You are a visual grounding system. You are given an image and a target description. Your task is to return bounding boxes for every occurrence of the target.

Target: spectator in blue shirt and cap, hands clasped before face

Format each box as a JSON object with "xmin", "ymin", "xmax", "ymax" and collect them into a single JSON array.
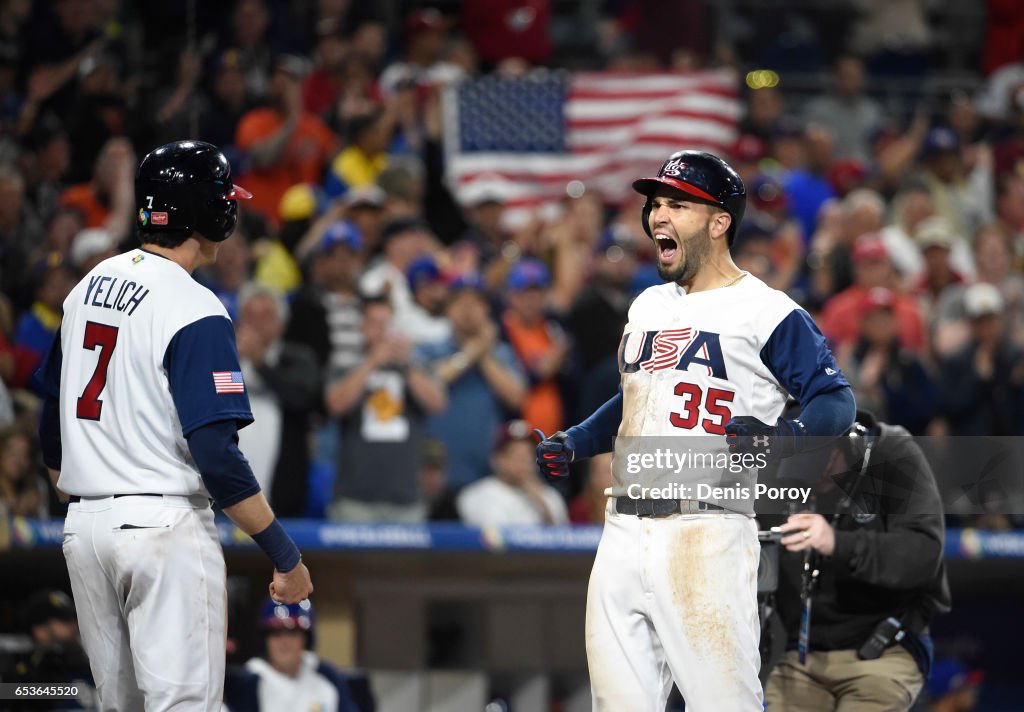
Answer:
[{"xmin": 420, "ymin": 274, "xmax": 526, "ymax": 488}]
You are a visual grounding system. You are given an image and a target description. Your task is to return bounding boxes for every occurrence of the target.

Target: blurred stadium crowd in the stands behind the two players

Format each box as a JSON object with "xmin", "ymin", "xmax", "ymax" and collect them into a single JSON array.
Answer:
[{"xmin": 0, "ymin": 0, "xmax": 1024, "ymax": 528}]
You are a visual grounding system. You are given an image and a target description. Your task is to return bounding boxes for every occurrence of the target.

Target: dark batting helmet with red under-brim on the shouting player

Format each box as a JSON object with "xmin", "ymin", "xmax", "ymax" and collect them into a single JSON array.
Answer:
[{"xmin": 633, "ymin": 151, "xmax": 746, "ymax": 246}]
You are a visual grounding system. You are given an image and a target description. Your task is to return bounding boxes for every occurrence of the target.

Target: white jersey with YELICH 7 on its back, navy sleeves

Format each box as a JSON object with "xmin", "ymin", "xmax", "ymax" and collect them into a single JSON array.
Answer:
[{"xmin": 43, "ymin": 250, "xmax": 252, "ymax": 496}]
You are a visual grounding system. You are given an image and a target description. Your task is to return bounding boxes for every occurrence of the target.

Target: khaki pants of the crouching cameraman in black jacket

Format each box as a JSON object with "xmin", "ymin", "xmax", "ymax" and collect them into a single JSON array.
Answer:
[{"xmin": 765, "ymin": 645, "xmax": 925, "ymax": 712}]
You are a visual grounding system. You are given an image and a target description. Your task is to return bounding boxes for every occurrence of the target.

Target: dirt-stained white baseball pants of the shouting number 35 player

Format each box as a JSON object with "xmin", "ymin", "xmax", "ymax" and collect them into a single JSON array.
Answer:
[{"xmin": 587, "ymin": 500, "xmax": 763, "ymax": 712}]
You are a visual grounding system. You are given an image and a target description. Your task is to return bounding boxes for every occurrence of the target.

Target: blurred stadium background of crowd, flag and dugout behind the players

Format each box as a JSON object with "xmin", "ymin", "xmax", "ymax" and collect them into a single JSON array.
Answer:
[{"xmin": 0, "ymin": 0, "xmax": 1024, "ymax": 712}]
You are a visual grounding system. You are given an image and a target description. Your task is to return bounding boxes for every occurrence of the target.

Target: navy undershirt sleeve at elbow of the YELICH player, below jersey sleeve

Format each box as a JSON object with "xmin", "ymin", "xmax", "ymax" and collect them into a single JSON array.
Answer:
[{"xmin": 188, "ymin": 420, "xmax": 260, "ymax": 509}]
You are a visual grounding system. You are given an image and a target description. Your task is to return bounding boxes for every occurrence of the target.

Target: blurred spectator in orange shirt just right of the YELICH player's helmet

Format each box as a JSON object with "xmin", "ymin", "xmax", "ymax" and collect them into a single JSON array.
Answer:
[{"xmin": 234, "ymin": 55, "xmax": 338, "ymax": 226}]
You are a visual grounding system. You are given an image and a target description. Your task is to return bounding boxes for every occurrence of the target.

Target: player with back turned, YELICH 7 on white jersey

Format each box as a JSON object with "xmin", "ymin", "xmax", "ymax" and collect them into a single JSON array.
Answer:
[{"xmin": 40, "ymin": 141, "xmax": 312, "ymax": 712}]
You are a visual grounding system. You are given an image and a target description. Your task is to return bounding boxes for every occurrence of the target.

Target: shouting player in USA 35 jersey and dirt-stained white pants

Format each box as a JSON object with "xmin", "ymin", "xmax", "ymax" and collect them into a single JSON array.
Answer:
[{"xmin": 538, "ymin": 151, "xmax": 855, "ymax": 712}]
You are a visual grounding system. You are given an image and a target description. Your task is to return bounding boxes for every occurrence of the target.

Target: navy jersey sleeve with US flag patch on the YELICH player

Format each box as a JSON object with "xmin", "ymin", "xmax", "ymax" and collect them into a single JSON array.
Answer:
[{"xmin": 164, "ymin": 317, "xmax": 253, "ymax": 437}]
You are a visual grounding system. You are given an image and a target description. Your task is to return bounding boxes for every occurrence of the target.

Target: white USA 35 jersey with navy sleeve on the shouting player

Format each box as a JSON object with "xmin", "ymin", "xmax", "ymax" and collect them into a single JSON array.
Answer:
[{"xmin": 612, "ymin": 275, "xmax": 847, "ymax": 513}]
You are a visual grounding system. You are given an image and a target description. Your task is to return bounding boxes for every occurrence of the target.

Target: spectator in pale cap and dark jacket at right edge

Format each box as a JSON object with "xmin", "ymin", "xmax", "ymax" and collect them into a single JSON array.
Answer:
[{"xmin": 939, "ymin": 282, "xmax": 1024, "ymax": 435}]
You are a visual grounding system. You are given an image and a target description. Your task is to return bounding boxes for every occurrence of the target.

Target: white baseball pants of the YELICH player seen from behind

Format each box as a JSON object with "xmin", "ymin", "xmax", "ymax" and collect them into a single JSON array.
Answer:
[{"xmin": 63, "ymin": 496, "xmax": 226, "ymax": 712}]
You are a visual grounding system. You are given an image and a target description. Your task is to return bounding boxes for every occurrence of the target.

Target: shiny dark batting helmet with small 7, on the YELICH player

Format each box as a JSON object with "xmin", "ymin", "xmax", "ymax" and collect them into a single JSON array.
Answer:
[{"xmin": 135, "ymin": 141, "xmax": 252, "ymax": 247}]
